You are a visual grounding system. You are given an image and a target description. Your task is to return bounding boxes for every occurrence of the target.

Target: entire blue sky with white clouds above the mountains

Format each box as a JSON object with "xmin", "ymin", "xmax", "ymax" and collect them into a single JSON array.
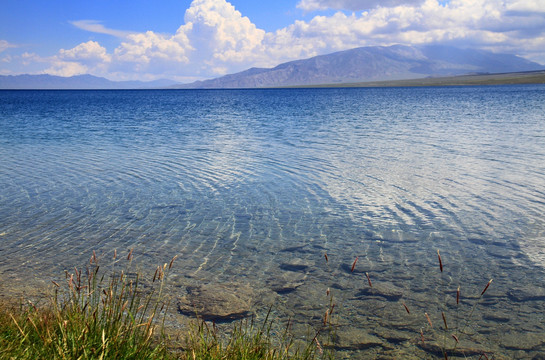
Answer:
[{"xmin": 0, "ymin": 0, "xmax": 545, "ymax": 82}]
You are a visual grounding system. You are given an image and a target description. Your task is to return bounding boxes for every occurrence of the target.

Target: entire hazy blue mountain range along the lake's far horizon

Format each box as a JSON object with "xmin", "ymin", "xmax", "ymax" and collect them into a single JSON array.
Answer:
[{"xmin": 0, "ymin": 45, "xmax": 545, "ymax": 89}]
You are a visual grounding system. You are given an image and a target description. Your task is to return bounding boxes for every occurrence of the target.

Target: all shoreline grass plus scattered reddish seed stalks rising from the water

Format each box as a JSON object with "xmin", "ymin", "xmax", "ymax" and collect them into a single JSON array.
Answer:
[{"xmin": 0, "ymin": 250, "xmax": 497, "ymax": 360}]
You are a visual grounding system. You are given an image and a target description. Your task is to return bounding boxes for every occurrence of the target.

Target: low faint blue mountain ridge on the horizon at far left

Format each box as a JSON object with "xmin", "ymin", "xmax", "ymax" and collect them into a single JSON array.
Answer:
[{"xmin": 0, "ymin": 75, "xmax": 181, "ymax": 90}]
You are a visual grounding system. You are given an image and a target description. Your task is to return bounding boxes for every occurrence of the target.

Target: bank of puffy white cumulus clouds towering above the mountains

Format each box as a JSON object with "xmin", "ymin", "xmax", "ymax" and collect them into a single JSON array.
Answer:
[{"xmin": 18, "ymin": 0, "xmax": 545, "ymax": 80}]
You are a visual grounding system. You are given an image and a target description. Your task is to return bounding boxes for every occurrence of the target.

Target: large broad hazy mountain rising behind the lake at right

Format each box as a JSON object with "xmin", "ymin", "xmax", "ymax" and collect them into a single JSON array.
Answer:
[{"xmin": 176, "ymin": 45, "xmax": 545, "ymax": 88}]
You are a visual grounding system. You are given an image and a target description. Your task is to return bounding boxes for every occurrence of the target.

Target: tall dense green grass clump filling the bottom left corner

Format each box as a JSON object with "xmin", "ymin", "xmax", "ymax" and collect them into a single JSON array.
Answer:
[{"xmin": 0, "ymin": 252, "xmax": 172, "ymax": 360}]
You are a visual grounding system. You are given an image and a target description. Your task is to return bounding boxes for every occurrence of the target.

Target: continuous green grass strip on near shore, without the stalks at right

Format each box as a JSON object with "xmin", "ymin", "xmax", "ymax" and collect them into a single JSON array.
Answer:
[{"xmin": 0, "ymin": 253, "xmax": 332, "ymax": 360}]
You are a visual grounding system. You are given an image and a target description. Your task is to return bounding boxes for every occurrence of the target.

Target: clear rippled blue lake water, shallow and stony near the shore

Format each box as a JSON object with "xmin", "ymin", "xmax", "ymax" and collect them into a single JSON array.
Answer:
[{"xmin": 0, "ymin": 86, "xmax": 545, "ymax": 358}]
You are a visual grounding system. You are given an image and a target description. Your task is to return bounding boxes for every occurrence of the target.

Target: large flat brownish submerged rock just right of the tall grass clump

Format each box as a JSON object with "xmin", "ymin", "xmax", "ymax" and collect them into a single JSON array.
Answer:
[{"xmin": 178, "ymin": 283, "xmax": 254, "ymax": 321}]
